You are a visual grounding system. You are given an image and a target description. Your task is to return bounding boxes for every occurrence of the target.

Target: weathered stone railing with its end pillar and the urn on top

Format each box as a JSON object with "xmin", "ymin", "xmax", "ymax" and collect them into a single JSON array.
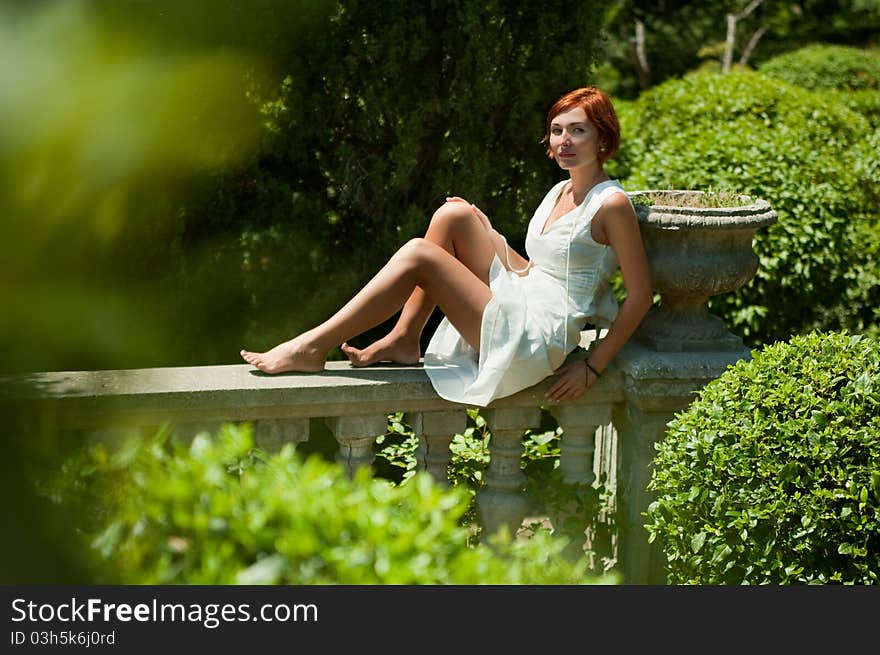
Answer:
[{"xmin": 6, "ymin": 191, "xmax": 776, "ymax": 584}]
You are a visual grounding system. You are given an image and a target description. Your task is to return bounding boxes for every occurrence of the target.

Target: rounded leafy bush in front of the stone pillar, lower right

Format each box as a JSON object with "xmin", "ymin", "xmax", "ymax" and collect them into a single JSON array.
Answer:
[{"xmin": 646, "ymin": 332, "xmax": 880, "ymax": 584}]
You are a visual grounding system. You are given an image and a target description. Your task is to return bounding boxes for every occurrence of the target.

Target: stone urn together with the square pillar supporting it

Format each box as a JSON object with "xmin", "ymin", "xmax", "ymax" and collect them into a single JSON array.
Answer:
[{"xmin": 614, "ymin": 191, "xmax": 776, "ymax": 584}]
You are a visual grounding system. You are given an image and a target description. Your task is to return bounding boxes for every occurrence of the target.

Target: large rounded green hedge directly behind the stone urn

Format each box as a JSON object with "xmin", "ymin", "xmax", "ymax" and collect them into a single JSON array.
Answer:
[{"xmin": 611, "ymin": 69, "xmax": 880, "ymax": 346}]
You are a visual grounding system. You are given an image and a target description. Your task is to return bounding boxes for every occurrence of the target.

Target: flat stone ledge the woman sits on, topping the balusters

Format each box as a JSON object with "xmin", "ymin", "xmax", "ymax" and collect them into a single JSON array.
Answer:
[{"xmin": 0, "ymin": 362, "xmax": 622, "ymax": 428}]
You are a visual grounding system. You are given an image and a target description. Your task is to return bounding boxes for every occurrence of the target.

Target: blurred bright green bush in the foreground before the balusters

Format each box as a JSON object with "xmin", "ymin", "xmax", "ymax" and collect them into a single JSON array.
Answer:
[{"xmin": 50, "ymin": 426, "xmax": 612, "ymax": 584}]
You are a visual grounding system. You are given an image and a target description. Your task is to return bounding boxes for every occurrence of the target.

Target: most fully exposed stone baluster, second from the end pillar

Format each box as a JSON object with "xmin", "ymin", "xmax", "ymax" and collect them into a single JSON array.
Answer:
[{"xmin": 477, "ymin": 407, "xmax": 541, "ymax": 536}]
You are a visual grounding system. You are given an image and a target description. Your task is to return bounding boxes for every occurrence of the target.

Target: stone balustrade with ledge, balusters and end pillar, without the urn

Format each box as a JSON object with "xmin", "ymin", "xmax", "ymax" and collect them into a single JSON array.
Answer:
[{"xmin": 0, "ymin": 330, "xmax": 749, "ymax": 584}]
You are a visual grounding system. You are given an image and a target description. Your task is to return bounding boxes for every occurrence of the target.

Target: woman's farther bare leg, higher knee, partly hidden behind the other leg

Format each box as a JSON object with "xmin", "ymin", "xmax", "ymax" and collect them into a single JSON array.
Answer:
[{"xmin": 342, "ymin": 202, "xmax": 496, "ymax": 366}]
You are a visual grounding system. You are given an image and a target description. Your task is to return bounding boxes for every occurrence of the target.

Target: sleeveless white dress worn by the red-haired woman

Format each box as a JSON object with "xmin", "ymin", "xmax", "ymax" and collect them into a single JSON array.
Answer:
[{"xmin": 424, "ymin": 180, "xmax": 625, "ymax": 407}]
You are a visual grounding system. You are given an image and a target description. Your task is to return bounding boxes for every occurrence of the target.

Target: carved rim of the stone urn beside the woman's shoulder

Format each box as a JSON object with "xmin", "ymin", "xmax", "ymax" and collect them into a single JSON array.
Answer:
[{"xmin": 627, "ymin": 189, "xmax": 777, "ymax": 230}]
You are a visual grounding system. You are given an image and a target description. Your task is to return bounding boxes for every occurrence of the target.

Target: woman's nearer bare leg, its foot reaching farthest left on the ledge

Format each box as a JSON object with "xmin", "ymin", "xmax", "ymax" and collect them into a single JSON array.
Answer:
[{"xmin": 241, "ymin": 232, "xmax": 494, "ymax": 373}]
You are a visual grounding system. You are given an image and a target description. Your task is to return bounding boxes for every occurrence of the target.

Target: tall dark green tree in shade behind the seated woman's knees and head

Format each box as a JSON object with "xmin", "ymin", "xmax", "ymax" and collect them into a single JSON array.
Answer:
[{"xmin": 178, "ymin": 0, "xmax": 601, "ymax": 357}]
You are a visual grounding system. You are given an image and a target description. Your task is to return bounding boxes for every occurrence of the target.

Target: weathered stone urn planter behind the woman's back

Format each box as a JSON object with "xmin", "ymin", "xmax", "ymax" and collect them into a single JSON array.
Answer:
[{"xmin": 629, "ymin": 190, "xmax": 776, "ymax": 352}]
